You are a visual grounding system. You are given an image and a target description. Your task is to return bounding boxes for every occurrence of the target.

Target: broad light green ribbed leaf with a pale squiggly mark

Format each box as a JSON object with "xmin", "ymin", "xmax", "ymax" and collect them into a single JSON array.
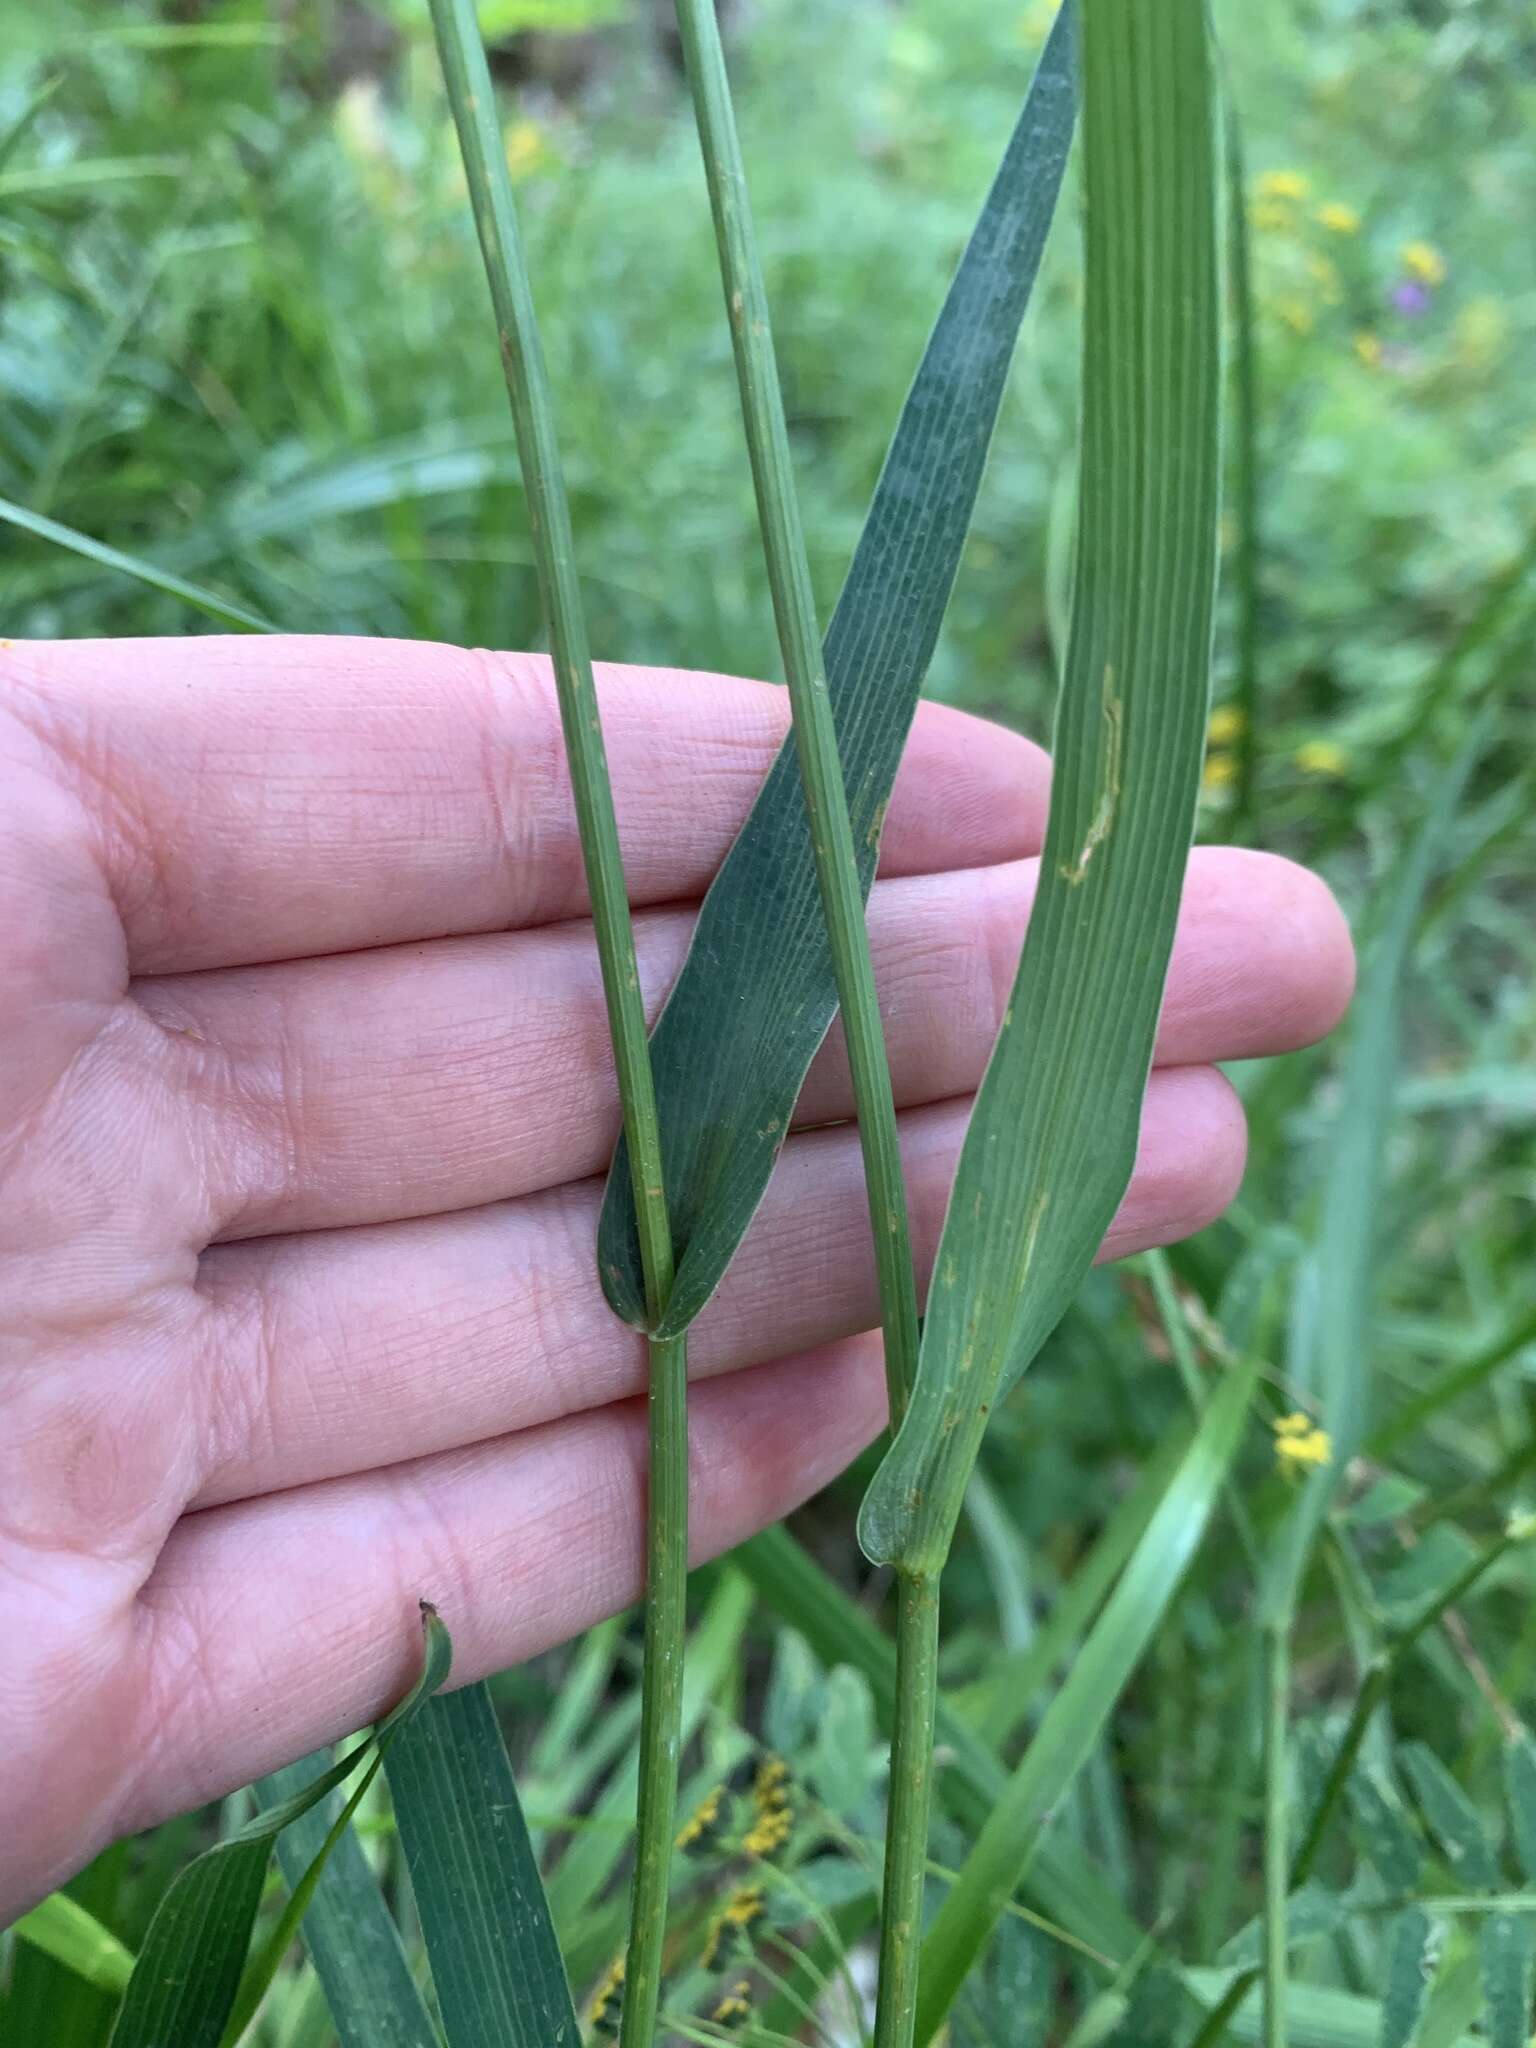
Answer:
[{"xmin": 860, "ymin": 0, "xmax": 1221, "ymax": 1573}]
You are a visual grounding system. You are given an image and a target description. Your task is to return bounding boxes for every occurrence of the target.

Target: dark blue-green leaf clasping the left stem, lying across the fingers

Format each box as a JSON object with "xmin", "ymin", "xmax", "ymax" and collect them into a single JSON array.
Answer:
[{"xmin": 598, "ymin": 8, "xmax": 1075, "ymax": 1335}]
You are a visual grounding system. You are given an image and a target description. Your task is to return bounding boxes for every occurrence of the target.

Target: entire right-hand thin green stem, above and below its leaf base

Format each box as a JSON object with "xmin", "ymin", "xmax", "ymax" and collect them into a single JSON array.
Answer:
[{"xmin": 663, "ymin": 0, "xmax": 921, "ymax": 2048}]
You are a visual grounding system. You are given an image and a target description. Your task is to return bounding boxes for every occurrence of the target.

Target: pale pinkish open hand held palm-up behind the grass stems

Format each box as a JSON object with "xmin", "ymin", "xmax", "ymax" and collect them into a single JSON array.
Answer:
[{"xmin": 0, "ymin": 639, "xmax": 1354, "ymax": 1923}]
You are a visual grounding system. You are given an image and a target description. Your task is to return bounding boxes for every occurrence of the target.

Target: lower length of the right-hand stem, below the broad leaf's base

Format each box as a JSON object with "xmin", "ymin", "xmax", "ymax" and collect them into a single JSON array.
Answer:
[{"xmin": 874, "ymin": 1571, "xmax": 938, "ymax": 2048}]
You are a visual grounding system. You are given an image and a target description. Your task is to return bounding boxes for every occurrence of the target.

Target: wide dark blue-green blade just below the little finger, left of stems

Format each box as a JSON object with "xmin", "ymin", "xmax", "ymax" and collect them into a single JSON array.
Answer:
[{"xmin": 385, "ymin": 1686, "xmax": 580, "ymax": 2048}]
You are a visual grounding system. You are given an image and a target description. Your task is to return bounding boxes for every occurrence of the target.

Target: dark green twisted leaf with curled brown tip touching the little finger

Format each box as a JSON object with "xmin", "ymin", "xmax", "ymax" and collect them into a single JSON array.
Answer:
[{"xmin": 113, "ymin": 1608, "xmax": 453, "ymax": 2048}]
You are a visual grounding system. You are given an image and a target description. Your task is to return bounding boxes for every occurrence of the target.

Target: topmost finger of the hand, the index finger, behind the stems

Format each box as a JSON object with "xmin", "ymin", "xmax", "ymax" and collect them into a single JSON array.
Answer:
[{"xmin": 0, "ymin": 635, "xmax": 1047, "ymax": 973}]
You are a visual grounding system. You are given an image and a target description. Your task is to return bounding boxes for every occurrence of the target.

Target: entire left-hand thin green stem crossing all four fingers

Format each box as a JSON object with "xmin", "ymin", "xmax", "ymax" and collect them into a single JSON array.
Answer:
[{"xmin": 421, "ymin": 0, "xmax": 688, "ymax": 2048}]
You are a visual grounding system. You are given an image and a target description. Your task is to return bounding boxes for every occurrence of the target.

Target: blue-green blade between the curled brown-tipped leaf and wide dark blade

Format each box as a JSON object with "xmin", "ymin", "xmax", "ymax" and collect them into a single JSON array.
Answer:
[{"xmin": 256, "ymin": 1751, "xmax": 438, "ymax": 2048}]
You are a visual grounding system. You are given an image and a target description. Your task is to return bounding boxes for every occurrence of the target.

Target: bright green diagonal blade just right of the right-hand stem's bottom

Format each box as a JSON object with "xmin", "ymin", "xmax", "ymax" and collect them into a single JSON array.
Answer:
[{"xmin": 918, "ymin": 1362, "xmax": 1257, "ymax": 2042}]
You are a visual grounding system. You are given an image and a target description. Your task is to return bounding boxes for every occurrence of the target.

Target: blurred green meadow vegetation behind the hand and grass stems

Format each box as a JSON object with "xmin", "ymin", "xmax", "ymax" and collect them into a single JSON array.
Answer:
[{"xmin": 0, "ymin": 0, "xmax": 1536, "ymax": 2048}]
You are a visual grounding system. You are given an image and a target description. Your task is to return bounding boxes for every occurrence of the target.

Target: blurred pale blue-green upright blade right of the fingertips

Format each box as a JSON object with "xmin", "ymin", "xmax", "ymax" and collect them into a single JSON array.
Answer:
[{"xmin": 1264, "ymin": 719, "xmax": 1487, "ymax": 1614}]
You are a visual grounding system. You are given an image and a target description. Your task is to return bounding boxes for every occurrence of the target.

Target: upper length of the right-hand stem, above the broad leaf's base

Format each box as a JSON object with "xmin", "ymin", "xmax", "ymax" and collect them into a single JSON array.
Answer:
[{"xmin": 678, "ymin": 0, "xmax": 918, "ymax": 1427}]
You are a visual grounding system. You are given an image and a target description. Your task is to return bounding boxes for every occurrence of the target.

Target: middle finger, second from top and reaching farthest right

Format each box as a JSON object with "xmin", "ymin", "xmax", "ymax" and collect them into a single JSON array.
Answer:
[{"xmin": 135, "ymin": 848, "xmax": 1350, "ymax": 1241}]
